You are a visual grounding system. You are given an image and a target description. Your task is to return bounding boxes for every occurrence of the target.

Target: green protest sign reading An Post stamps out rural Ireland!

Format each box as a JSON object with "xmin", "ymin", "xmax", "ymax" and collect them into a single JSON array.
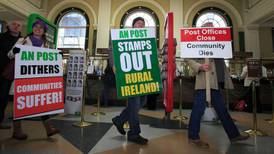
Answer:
[{"xmin": 111, "ymin": 28, "xmax": 162, "ymax": 98}]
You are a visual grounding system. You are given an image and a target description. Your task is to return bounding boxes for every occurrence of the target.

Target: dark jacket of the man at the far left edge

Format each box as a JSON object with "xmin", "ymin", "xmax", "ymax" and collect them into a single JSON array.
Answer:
[{"xmin": 0, "ymin": 31, "xmax": 21, "ymax": 72}]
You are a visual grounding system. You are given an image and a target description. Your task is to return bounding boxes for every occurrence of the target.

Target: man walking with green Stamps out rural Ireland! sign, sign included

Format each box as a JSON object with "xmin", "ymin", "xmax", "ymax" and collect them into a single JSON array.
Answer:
[{"xmin": 110, "ymin": 17, "xmax": 162, "ymax": 144}]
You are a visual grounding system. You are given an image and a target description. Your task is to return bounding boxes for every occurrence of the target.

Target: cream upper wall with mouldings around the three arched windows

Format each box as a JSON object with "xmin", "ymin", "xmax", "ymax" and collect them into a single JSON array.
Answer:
[{"xmin": 3, "ymin": 0, "xmax": 274, "ymax": 62}]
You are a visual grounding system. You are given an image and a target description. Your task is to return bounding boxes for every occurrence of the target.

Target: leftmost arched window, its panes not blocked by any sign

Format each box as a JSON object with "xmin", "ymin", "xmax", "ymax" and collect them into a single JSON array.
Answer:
[{"xmin": 55, "ymin": 8, "xmax": 89, "ymax": 49}]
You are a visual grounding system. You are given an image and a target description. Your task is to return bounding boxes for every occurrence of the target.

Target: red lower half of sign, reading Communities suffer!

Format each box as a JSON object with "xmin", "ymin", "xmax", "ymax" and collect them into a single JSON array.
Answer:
[{"xmin": 14, "ymin": 77, "xmax": 64, "ymax": 119}]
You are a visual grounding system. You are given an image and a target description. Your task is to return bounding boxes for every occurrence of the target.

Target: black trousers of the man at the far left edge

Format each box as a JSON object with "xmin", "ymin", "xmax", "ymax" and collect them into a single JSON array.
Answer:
[{"xmin": 0, "ymin": 76, "xmax": 12, "ymax": 123}]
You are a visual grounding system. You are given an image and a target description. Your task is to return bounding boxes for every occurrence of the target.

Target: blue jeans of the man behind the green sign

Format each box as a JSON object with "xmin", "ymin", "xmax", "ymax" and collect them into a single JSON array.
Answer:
[{"xmin": 117, "ymin": 96, "xmax": 146, "ymax": 137}]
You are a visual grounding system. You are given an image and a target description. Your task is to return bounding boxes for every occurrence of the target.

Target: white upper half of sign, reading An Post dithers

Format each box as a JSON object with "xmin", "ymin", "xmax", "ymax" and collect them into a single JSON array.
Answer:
[{"xmin": 15, "ymin": 45, "xmax": 63, "ymax": 79}]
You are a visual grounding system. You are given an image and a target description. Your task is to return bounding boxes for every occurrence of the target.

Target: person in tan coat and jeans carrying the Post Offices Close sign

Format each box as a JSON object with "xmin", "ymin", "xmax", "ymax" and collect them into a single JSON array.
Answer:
[{"xmin": 186, "ymin": 23, "xmax": 249, "ymax": 148}]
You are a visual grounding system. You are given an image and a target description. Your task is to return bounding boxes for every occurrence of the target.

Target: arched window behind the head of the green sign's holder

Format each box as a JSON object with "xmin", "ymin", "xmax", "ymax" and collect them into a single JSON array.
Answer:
[{"xmin": 120, "ymin": 6, "xmax": 160, "ymax": 47}]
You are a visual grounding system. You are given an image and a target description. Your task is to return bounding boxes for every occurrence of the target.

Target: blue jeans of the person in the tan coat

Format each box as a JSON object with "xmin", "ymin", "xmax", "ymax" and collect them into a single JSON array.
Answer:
[{"xmin": 188, "ymin": 89, "xmax": 240, "ymax": 140}]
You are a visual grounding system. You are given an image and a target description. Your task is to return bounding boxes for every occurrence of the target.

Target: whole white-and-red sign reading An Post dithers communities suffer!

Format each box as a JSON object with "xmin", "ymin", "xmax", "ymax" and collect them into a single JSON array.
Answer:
[{"xmin": 13, "ymin": 45, "xmax": 64, "ymax": 119}]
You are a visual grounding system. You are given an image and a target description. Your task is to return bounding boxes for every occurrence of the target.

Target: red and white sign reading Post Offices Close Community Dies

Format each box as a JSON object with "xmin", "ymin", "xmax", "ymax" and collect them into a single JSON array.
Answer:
[{"xmin": 181, "ymin": 27, "xmax": 232, "ymax": 59}]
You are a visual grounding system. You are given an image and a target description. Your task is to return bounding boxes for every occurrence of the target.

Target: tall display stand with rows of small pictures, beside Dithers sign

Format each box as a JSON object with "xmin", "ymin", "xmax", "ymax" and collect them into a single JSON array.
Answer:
[{"xmin": 65, "ymin": 50, "xmax": 86, "ymax": 114}]
